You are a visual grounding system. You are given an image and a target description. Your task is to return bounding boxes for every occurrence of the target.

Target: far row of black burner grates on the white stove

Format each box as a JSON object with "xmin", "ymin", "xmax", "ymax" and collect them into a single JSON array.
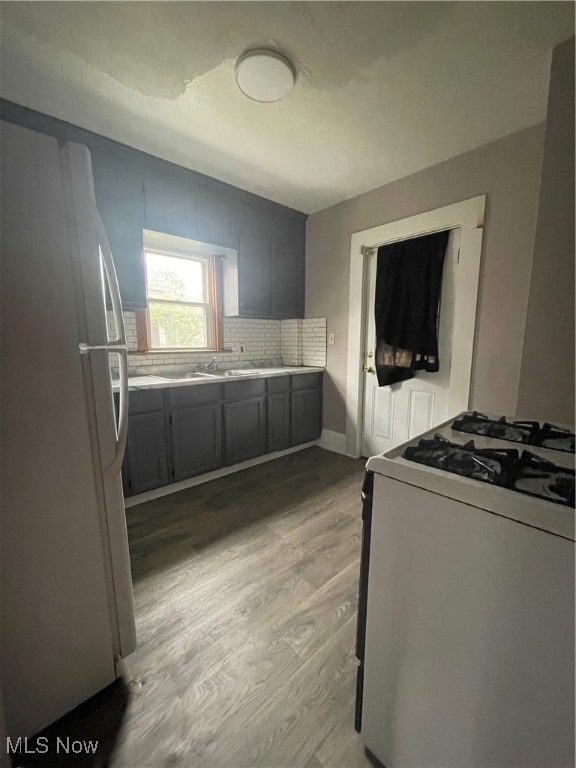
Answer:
[{"xmin": 452, "ymin": 411, "xmax": 574, "ymax": 453}]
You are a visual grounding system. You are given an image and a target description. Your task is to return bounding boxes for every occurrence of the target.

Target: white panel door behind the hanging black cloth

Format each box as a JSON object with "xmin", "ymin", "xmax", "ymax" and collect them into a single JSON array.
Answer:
[{"xmin": 362, "ymin": 229, "xmax": 460, "ymax": 456}]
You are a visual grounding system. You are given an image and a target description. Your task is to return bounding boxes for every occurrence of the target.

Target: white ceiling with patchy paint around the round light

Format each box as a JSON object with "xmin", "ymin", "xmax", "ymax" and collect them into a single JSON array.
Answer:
[{"xmin": 0, "ymin": 0, "xmax": 574, "ymax": 213}]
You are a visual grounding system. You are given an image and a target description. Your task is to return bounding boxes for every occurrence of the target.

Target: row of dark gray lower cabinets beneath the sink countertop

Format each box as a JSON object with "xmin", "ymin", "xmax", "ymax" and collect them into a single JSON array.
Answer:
[{"xmin": 122, "ymin": 373, "xmax": 322, "ymax": 496}]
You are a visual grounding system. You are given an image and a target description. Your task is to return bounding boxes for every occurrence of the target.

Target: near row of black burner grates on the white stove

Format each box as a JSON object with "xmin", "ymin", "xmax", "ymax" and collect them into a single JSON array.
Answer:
[{"xmin": 402, "ymin": 433, "xmax": 574, "ymax": 506}]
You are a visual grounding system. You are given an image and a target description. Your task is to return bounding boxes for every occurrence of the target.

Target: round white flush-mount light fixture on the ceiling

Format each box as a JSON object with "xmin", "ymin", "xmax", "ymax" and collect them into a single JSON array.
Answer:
[{"xmin": 236, "ymin": 48, "xmax": 296, "ymax": 101}]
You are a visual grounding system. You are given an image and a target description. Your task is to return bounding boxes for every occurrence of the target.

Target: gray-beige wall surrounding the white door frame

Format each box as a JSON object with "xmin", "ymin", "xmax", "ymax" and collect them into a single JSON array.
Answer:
[{"xmin": 306, "ymin": 124, "xmax": 545, "ymax": 432}]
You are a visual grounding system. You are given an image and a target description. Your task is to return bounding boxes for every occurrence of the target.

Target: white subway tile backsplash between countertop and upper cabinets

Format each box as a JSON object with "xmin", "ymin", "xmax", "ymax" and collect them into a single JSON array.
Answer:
[{"xmin": 108, "ymin": 312, "xmax": 326, "ymax": 373}]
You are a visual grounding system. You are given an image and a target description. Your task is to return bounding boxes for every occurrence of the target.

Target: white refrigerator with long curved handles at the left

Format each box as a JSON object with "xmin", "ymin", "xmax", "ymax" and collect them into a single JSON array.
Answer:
[{"xmin": 0, "ymin": 122, "xmax": 136, "ymax": 739}]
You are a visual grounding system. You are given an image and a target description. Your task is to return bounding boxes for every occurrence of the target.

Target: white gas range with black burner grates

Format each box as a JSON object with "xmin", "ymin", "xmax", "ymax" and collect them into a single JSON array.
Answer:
[{"xmin": 356, "ymin": 413, "xmax": 575, "ymax": 768}]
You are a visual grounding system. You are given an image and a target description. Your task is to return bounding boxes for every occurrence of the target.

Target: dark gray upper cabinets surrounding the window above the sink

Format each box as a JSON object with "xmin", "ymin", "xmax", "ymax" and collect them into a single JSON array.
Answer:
[{"xmin": 0, "ymin": 100, "xmax": 306, "ymax": 319}]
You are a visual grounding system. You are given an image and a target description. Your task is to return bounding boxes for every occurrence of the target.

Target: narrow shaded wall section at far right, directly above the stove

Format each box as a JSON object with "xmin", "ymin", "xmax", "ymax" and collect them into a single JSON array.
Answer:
[{"xmin": 518, "ymin": 38, "xmax": 574, "ymax": 424}]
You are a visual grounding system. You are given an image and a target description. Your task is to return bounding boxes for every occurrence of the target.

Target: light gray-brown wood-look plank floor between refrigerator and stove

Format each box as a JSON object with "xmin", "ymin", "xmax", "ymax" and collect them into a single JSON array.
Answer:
[{"xmin": 109, "ymin": 448, "xmax": 378, "ymax": 768}]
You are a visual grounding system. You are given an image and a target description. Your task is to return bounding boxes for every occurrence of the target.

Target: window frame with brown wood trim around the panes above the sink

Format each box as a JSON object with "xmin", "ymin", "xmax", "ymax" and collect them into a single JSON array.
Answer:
[{"xmin": 136, "ymin": 230, "xmax": 224, "ymax": 355}]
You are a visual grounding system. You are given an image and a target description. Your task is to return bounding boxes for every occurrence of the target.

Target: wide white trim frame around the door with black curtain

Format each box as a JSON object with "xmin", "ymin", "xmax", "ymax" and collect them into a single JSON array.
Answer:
[{"xmin": 346, "ymin": 195, "xmax": 486, "ymax": 457}]
